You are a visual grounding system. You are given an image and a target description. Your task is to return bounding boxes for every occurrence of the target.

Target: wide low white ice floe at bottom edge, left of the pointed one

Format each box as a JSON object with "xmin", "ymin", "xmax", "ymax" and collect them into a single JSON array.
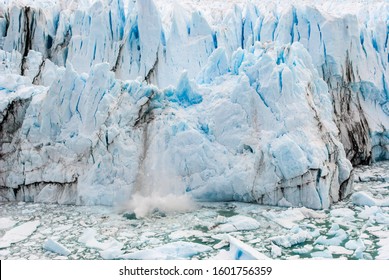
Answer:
[{"xmin": 118, "ymin": 241, "xmax": 212, "ymax": 260}]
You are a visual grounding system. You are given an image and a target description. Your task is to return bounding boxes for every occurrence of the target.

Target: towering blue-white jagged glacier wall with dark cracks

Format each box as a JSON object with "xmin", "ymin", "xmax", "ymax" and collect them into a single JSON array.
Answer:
[{"xmin": 0, "ymin": 0, "xmax": 389, "ymax": 209}]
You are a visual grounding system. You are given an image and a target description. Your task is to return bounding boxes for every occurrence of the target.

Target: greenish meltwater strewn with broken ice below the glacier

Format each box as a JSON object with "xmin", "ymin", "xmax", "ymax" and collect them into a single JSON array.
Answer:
[{"xmin": 0, "ymin": 161, "xmax": 389, "ymax": 259}]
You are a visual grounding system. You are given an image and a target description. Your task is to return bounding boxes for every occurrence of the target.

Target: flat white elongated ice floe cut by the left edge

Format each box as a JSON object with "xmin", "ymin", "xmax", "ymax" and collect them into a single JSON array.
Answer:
[{"xmin": 0, "ymin": 220, "xmax": 40, "ymax": 249}]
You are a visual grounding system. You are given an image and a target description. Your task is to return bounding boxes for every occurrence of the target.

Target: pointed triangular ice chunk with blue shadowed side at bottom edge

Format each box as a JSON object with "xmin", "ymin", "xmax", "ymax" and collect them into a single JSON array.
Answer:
[{"xmin": 212, "ymin": 236, "xmax": 269, "ymax": 260}]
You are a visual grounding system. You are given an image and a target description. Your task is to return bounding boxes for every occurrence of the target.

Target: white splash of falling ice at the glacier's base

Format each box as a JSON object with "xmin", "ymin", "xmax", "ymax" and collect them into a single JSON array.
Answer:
[{"xmin": 126, "ymin": 192, "xmax": 196, "ymax": 218}]
